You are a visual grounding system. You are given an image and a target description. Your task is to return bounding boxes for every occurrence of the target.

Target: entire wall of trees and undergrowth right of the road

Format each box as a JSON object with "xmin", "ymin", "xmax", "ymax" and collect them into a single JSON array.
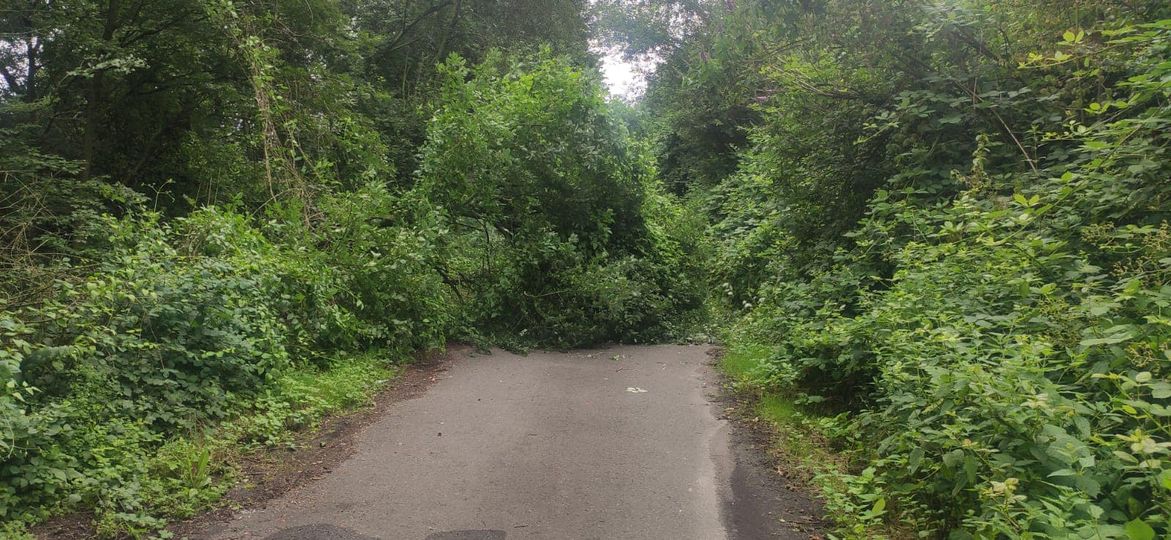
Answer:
[{"xmin": 610, "ymin": 0, "xmax": 1171, "ymax": 539}]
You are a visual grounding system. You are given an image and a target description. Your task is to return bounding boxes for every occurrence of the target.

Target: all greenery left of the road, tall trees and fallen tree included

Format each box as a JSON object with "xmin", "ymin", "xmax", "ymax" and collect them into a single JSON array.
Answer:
[{"xmin": 0, "ymin": 0, "xmax": 705, "ymax": 536}]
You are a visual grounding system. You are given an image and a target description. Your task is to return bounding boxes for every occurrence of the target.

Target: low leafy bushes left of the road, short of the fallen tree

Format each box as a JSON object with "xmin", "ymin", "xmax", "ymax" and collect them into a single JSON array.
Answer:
[{"xmin": 0, "ymin": 187, "xmax": 450, "ymax": 527}]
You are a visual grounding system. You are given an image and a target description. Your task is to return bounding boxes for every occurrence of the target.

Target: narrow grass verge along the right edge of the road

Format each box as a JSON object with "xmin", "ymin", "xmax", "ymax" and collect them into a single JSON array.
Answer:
[{"xmin": 719, "ymin": 343, "xmax": 913, "ymax": 540}]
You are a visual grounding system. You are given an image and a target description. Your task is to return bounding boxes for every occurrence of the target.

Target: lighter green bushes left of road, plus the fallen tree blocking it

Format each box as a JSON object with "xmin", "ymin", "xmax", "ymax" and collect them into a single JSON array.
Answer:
[{"xmin": 0, "ymin": 36, "xmax": 704, "ymax": 535}]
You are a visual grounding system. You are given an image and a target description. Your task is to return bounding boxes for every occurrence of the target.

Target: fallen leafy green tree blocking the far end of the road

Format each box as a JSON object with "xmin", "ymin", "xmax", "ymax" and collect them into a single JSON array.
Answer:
[{"xmin": 417, "ymin": 52, "xmax": 704, "ymax": 347}]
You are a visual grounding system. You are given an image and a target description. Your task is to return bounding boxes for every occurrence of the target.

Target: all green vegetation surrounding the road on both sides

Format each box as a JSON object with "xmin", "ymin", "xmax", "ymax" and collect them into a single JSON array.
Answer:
[{"xmin": 0, "ymin": 0, "xmax": 1171, "ymax": 540}]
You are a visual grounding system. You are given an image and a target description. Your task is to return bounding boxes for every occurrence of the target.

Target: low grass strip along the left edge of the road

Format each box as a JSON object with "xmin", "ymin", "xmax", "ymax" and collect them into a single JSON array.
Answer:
[{"xmin": 38, "ymin": 350, "xmax": 404, "ymax": 540}]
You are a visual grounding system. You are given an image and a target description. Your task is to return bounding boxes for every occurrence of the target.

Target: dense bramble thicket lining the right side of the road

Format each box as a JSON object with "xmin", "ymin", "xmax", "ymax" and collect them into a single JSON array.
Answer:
[{"xmin": 708, "ymin": 12, "xmax": 1171, "ymax": 539}]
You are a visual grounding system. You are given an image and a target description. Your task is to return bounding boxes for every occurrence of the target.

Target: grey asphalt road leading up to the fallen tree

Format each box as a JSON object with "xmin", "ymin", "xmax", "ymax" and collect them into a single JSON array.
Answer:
[{"xmin": 197, "ymin": 346, "xmax": 816, "ymax": 540}]
